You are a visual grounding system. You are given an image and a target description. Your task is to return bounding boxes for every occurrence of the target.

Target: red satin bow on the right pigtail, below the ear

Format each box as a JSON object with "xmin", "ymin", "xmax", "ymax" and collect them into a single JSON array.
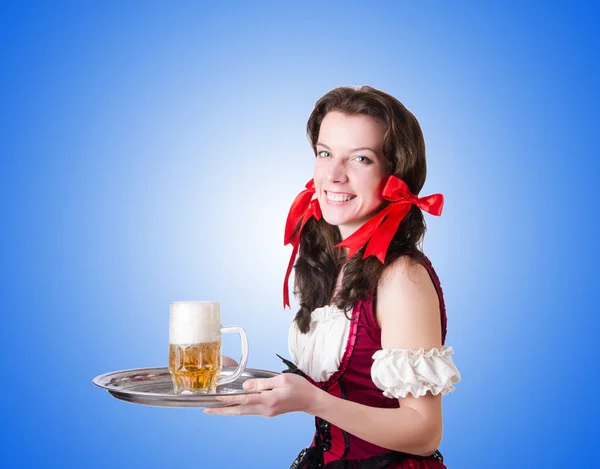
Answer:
[{"xmin": 336, "ymin": 176, "xmax": 444, "ymax": 264}]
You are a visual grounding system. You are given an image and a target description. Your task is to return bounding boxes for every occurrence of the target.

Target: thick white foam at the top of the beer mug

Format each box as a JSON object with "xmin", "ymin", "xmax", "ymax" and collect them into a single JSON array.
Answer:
[{"xmin": 169, "ymin": 301, "xmax": 221, "ymax": 345}]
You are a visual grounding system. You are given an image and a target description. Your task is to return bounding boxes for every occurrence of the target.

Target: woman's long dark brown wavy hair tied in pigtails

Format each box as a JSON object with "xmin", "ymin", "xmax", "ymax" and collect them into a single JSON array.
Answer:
[{"xmin": 294, "ymin": 86, "xmax": 427, "ymax": 333}]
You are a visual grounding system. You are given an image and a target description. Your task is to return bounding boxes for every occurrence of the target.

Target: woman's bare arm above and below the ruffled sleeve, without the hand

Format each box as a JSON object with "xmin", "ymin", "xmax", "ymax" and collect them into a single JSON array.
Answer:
[{"xmin": 314, "ymin": 257, "xmax": 442, "ymax": 455}]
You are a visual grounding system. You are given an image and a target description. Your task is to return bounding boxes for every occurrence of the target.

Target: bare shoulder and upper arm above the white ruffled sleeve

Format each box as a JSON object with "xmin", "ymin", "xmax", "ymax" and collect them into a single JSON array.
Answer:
[{"xmin": 376, "ymin": 256, "xmax": 441, "ymax": 350}]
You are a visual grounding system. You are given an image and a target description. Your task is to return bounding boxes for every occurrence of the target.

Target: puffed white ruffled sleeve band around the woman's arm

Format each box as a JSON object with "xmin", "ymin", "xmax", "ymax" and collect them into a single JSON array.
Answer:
[{"xmin": 371, "ymin": 346, "xmax": 460, "ymax": 399}]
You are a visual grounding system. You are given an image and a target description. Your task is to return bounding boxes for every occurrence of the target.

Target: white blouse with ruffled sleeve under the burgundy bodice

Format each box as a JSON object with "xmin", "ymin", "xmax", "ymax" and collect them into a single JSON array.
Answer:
[{"xmin": 288, "ymin": 305, "xmax": 460, "ymax": 398}]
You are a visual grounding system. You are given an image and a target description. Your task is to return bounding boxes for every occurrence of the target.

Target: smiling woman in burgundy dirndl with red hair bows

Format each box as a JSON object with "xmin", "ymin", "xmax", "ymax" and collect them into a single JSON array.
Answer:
[{"xmin": 206, "ymin": 87, "xmax": 460, "ymax": 469}]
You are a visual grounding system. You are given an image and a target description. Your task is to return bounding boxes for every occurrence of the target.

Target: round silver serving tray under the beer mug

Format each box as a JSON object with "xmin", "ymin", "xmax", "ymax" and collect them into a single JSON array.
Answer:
[{"xmin": 92, "ymin": 367, "xmax": 279, "ymax": 407}]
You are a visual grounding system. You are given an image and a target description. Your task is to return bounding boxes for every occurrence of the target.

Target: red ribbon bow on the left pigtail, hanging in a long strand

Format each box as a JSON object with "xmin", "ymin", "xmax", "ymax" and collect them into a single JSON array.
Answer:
[{"xmin": 283, "ymin": 179, "xmax": 321, "ymax": 308}]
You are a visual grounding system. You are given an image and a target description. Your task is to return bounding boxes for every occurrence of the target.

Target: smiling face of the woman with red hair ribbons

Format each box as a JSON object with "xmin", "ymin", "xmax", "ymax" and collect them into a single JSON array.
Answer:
[{"xmin": 314, "ymin": 111, "xmax": 387, "ymax": 239}]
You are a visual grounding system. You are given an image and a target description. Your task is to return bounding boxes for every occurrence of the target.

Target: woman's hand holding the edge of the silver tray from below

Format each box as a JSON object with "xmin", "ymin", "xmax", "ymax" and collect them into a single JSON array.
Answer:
[{"xmin": 204, "ymin": 373, "xmax": 321, "ymax": 417}]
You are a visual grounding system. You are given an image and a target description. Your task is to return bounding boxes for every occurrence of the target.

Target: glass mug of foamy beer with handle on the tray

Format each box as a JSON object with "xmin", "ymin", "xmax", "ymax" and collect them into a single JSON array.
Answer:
[{"xmin": 169, "ymin": 301, "xmax": 248, "ymax": 394}]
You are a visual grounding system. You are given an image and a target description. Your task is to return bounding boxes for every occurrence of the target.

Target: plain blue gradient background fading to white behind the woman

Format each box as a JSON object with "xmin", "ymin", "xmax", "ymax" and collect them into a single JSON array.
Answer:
[{"xmin": 0, "ymin": 1, "xmax": 600, "ymax": 469}]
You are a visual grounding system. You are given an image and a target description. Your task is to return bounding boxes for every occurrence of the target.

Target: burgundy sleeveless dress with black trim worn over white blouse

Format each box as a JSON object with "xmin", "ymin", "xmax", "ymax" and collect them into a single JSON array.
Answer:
[{"xmin": 286, "ymin": 258, "xmax": 446, "ymax": 469}]
